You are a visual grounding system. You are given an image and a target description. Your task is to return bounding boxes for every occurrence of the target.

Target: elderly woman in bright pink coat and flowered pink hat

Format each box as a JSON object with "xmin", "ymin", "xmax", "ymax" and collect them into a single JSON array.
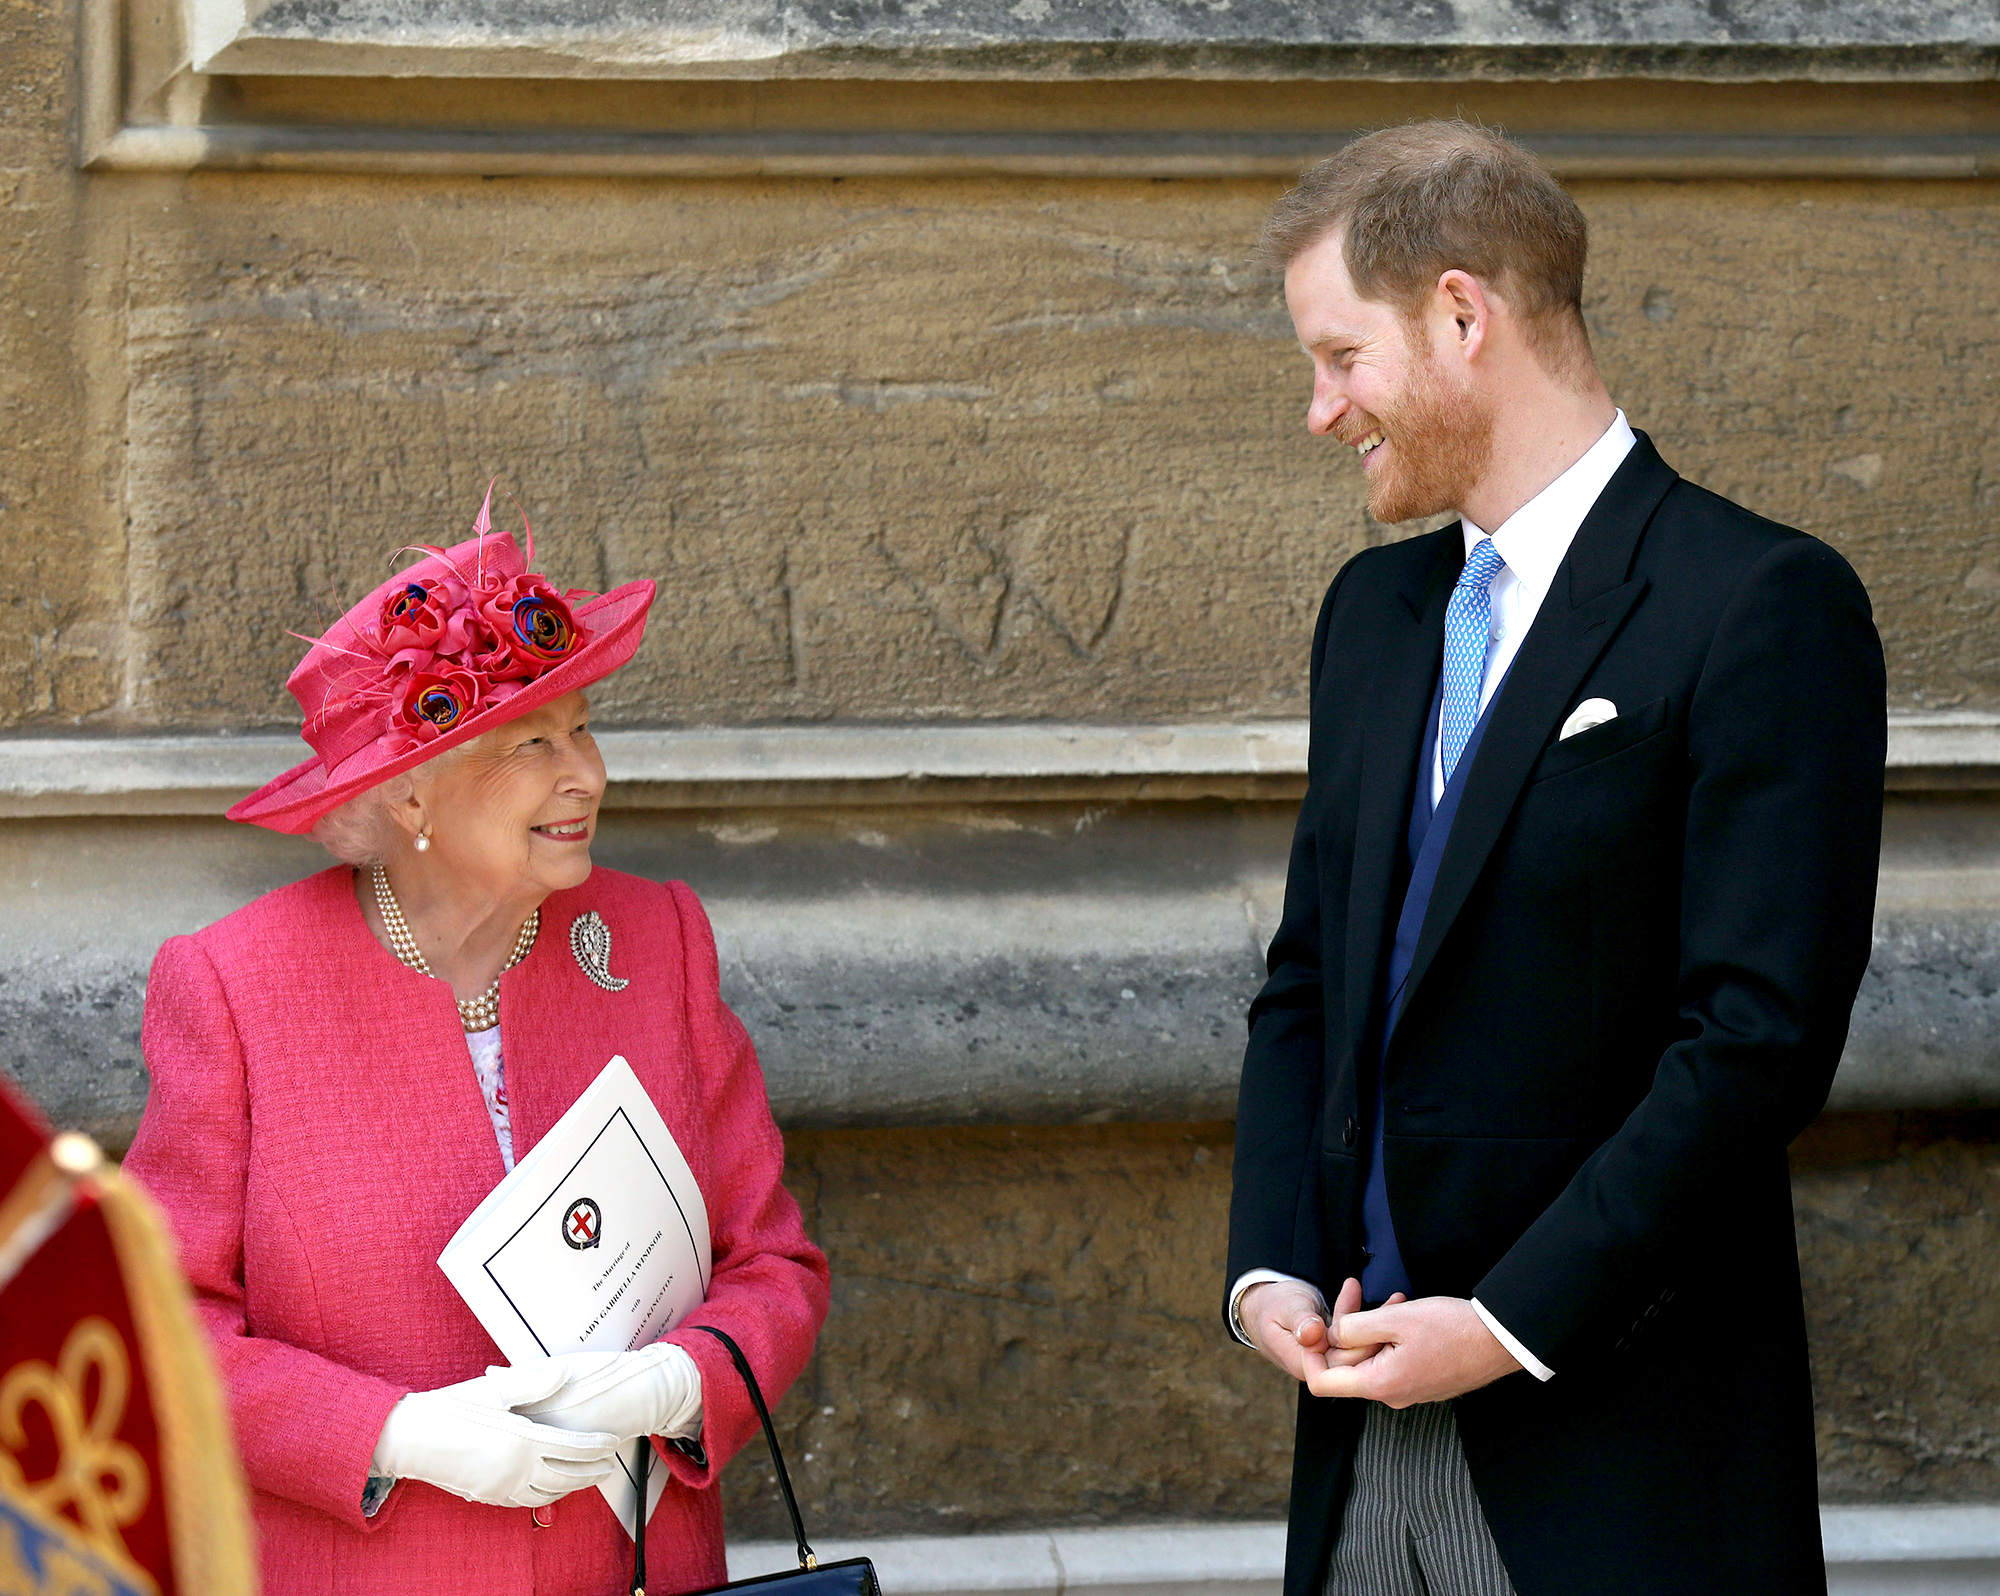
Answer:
[{"xmin": 126, "ymin": 494, "xmax": 828, "ymax": 1596}]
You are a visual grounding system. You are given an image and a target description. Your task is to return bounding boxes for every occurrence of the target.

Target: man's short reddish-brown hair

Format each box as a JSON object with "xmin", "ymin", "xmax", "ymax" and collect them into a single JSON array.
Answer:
[{"xmin": 1262, "ymin": 120, "xmax": 1590, "ymax": 368}]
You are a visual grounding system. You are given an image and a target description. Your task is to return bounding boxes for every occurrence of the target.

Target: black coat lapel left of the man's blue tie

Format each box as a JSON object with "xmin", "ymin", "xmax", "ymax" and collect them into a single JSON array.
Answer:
[{"xmin": 1346, "ymin": 536, "xmax": 1466, "ymax": 1072}]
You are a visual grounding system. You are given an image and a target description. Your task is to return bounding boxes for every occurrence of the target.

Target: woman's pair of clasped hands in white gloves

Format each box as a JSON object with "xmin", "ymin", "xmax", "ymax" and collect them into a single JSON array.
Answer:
[{"xmin": 372, "ymin": 1342, "xmax": 702, "ymax": 1508}]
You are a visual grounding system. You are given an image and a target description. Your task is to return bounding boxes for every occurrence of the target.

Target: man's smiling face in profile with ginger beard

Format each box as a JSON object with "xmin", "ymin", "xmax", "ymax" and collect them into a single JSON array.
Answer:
[{"xmin": 1284, "ymin": 232, "xmax": 1492, "ymax": 522}]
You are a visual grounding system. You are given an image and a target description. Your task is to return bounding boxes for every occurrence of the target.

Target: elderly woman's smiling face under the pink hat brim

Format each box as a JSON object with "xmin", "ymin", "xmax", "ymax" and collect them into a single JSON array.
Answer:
[{"xmin": 416, "ymin": 692, "xmax": 604, "ymax": 900}]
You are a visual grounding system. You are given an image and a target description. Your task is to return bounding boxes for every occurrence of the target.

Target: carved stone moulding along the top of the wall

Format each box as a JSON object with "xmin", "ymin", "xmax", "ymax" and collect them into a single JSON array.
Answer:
[{"xmin": 78, "ymin": 0, "xmax": 2000, "ymax": 180}]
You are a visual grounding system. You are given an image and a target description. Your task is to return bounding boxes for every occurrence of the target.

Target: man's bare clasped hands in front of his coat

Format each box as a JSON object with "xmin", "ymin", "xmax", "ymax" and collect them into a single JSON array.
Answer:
[{"xmin": 1236, "ymin": 1278, "xmax": 1520, "ymax": 1408}]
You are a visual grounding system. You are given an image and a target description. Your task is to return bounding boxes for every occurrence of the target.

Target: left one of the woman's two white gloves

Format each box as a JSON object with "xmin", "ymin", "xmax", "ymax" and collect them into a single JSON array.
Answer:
[{"xmin": 370, "ymin": 1360, "xmax": 618, "ymax": 1508}]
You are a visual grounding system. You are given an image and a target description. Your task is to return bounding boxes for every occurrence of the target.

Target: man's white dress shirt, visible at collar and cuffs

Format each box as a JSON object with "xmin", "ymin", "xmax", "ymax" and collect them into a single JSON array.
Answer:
[{"xmin": 1230, "ymin": 410, "xmax": 1638, "ymax": 1380}]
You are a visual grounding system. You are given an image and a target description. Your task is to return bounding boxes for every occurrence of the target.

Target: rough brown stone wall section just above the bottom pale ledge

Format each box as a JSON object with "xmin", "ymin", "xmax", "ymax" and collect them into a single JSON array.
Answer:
[{"xmin": 726, "ymin": 1114, "xmax": 2000, "ymax": 1536}]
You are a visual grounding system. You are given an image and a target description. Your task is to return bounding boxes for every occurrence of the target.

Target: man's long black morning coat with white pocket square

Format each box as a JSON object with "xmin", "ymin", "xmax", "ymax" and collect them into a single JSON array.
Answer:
[{"xmin": 1228, "ymin": 434, "xmax": 1886, "ymax": 1596}]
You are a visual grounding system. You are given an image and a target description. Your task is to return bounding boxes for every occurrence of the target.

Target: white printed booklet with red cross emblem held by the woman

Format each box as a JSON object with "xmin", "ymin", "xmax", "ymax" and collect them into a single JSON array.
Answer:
[{"xmin": 438, "ymin": 1056, "xmax": 710, "ymax": 1534}]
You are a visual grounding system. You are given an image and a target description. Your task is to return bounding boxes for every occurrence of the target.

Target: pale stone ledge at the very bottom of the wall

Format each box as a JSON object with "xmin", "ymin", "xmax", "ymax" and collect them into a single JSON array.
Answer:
[{"xmin": 730, "ymin": 1506, "xmax": 2000, "ymax": 1596}]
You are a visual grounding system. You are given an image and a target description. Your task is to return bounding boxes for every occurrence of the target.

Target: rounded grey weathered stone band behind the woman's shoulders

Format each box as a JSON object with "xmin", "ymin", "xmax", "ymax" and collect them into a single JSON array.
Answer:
[{"xmin": 0, "ymin": 796, "xmax": 2000, "ymax": 1148}]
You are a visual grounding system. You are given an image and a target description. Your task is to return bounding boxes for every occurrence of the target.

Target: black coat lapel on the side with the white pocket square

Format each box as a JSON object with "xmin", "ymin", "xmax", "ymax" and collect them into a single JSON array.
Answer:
[{"xmin": 1404, "ymin": 432, "xmax": 1678, "ymax": 1040}]
